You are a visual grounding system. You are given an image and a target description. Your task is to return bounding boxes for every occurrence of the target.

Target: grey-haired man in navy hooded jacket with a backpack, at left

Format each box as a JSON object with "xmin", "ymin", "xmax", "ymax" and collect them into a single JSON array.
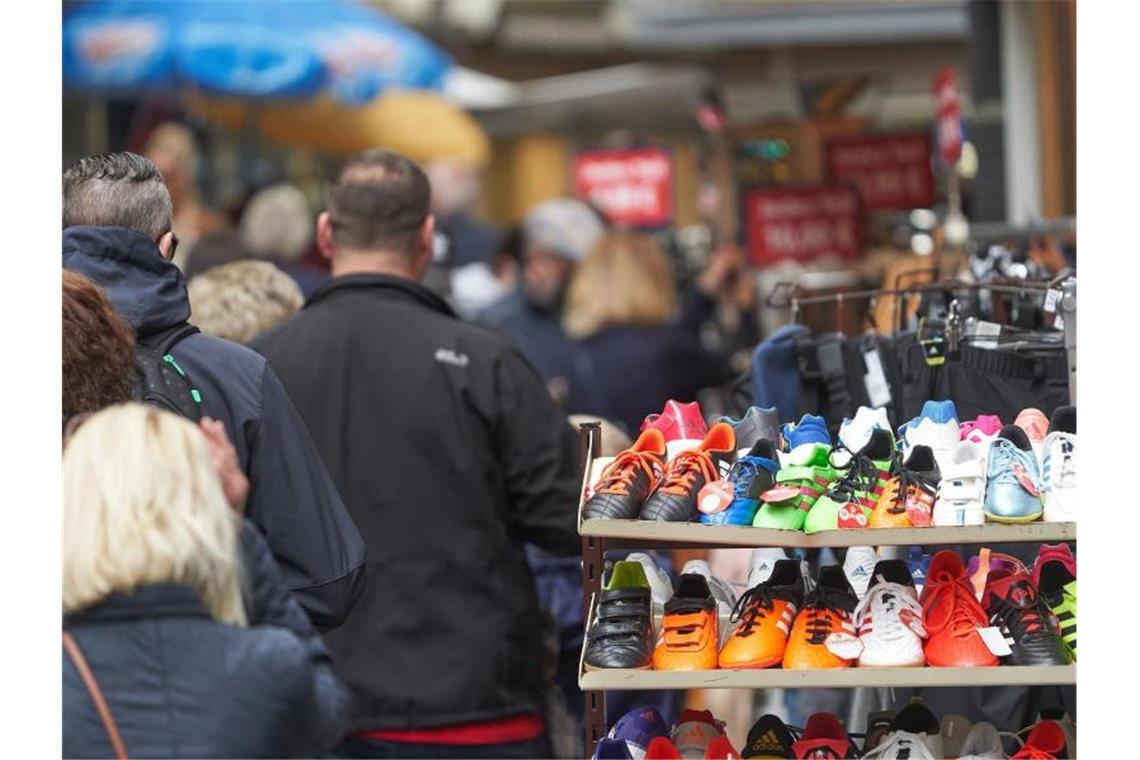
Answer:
[{"xmin": 63, "ymin": 153, "xmax": 365, "ymax": 628}]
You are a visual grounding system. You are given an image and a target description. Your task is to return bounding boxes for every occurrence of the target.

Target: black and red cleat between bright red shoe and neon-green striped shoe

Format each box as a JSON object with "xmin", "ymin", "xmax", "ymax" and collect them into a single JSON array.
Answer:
[{"xmin": 982, "ymin": 569, "xmax": 1072, "ymax": 665}]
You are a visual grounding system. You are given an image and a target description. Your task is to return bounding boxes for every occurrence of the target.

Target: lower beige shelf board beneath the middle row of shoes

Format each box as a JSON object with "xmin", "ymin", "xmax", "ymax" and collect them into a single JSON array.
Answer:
[{"xmin": 578, "ymin": 665, "xmax": 1076, "ymax": 690}]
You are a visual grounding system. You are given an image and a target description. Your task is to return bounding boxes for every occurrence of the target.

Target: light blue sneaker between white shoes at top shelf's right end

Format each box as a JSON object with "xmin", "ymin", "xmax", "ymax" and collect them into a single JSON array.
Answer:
[{"xmin": 985, "ymin": 425, "xmax": 1043, "ymax": 523}]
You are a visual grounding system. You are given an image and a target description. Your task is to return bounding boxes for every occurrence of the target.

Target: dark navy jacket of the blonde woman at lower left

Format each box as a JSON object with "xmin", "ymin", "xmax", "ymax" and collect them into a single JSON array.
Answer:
[{"xmin": 63, "ymin": 583, "xmax": 340, "ymax": 758}]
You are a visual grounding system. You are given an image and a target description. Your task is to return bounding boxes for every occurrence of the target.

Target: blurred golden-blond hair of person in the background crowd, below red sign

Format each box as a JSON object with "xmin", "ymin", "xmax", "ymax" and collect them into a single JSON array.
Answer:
[{"xmin": 563, "ymin": 232, "xmax": 677, "ymax": 338}]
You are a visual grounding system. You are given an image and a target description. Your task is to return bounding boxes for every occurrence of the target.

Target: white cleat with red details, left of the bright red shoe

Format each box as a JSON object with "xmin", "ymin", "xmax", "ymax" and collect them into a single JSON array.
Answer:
[{"xmin": 854, "ymin": 559, "xmax": 926, "ymax": 668}]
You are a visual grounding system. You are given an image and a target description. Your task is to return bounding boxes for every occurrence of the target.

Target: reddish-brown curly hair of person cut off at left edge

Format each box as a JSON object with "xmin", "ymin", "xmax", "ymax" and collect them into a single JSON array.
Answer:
[{"xmin": 63, "ymin": 269, "xmax": 136, "ymax": 422}]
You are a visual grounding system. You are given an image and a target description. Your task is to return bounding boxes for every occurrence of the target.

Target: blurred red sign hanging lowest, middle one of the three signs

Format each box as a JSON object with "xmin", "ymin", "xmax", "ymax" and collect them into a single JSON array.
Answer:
[{"xmin": 744, "ymin": 187, "xmax": 861, "ymax": 267}]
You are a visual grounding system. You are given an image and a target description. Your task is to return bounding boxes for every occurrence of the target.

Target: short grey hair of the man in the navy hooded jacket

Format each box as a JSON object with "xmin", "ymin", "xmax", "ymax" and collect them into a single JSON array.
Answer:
[{"xmin": 64, "ymin": 153, "xmax": 173, "ymax": 240}]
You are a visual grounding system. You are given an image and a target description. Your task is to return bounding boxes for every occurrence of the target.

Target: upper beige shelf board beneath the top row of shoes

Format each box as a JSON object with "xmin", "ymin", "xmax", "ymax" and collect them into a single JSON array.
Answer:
[{"xmin": 578, "ymin": 520, "xmax": 1076, "ymax": 549}]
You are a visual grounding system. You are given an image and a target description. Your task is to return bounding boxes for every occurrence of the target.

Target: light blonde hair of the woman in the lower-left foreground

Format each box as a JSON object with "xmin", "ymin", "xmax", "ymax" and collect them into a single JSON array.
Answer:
[{"xmin": 64, "ymin": 403, "xmax": 245, "ymax": 626}]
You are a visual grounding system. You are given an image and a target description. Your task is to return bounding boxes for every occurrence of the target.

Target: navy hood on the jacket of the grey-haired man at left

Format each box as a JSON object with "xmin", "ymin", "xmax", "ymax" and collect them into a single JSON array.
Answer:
[{"xmin": 63, "ymin": 226, "xmax": 190, "ymax": 337}]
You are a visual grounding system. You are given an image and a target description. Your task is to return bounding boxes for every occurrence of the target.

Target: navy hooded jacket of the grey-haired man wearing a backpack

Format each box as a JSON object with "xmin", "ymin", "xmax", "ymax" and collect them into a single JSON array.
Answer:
[{"xmin": 63, "ymin": 227, "xmax": 365, "ymax": 627}]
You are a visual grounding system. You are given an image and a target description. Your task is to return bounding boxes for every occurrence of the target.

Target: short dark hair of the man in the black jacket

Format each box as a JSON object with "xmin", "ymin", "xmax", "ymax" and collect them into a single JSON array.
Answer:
[{"xmin": 328, "ymin": 148, "xmax": 431, "ymax": 253}]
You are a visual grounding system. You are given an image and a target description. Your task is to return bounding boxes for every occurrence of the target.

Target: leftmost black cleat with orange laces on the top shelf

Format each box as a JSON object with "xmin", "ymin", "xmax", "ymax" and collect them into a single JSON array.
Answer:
[{"xmin": 583, "ymin": 428, "xmax": 665, "ymax": 520}]
